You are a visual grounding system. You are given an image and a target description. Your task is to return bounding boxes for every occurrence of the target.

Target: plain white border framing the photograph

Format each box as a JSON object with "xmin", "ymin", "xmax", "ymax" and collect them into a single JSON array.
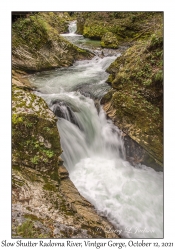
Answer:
[{"xmin": 0, "ymin": 0, "xmax": 175, "ymax": 249}]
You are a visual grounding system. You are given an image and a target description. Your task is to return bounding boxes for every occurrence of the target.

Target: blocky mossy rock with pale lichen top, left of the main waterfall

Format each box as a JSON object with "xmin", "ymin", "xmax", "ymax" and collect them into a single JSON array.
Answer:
[{"xmin": 12, "ymin": 87, "xmax": 62, "ymax": 180}]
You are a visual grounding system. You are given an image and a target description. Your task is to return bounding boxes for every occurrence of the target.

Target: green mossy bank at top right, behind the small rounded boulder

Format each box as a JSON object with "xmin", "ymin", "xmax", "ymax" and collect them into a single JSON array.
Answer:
[{"xmin": 77, "ymin": 11, "xmax": 163, "ymax": 44}]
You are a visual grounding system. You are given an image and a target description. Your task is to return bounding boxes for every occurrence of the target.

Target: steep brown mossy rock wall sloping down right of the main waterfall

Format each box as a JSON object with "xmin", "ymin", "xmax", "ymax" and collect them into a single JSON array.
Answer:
[{"xmin": 102, "ymin": 29, "xmax": 163, "ymax": 169}]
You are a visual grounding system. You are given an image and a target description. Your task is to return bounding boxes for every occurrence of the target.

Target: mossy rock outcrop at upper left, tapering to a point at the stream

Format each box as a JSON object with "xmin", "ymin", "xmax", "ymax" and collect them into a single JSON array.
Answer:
[{"xmin": 12, "ymin": 12, "xmax": 93, "ymax": 72}]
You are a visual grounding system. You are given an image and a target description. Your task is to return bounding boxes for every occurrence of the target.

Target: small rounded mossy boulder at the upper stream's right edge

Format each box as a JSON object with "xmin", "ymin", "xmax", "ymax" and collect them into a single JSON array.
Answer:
[{"xmin": 101, "ymin": 32, "xmax": 118, "ymax": 49}]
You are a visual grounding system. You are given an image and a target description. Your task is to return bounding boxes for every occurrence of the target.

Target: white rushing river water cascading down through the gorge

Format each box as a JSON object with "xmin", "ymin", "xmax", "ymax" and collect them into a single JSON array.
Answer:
[{"xmin": 30, "ymin": 21, "xmax": 163, "ymax": 238}]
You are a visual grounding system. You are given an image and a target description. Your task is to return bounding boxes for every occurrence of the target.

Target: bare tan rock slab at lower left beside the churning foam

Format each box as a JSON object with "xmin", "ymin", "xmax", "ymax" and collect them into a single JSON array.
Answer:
[{"xmin": 12, "ymin": 160, "xmax": 118, "ymax": 238}]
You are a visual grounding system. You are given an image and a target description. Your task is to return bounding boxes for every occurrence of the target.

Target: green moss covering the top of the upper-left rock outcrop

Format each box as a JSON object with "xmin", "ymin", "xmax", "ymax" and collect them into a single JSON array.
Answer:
[{"xmin": 12, "ymin": 12, "xmax": 68, "ymax": 52}]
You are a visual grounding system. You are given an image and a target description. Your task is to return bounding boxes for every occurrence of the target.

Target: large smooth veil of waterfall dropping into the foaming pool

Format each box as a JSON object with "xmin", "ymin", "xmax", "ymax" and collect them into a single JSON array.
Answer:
[{"xmin": 51, "ymin": 92, "xmax": 125, "ymax": 173}]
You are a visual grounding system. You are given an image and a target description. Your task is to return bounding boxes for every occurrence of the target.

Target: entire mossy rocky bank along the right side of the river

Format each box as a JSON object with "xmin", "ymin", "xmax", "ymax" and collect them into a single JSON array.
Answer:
[{"xmin": 77, "ymin": 12, "xmax": 163, "ymax": 170}]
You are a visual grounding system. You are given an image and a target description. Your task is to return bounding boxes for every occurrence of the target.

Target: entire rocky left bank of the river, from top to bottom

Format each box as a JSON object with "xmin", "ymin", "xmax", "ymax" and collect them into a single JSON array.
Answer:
[{"xmin": 12, "ymin": 13, "xmax": 118, "ymax": 238}]
